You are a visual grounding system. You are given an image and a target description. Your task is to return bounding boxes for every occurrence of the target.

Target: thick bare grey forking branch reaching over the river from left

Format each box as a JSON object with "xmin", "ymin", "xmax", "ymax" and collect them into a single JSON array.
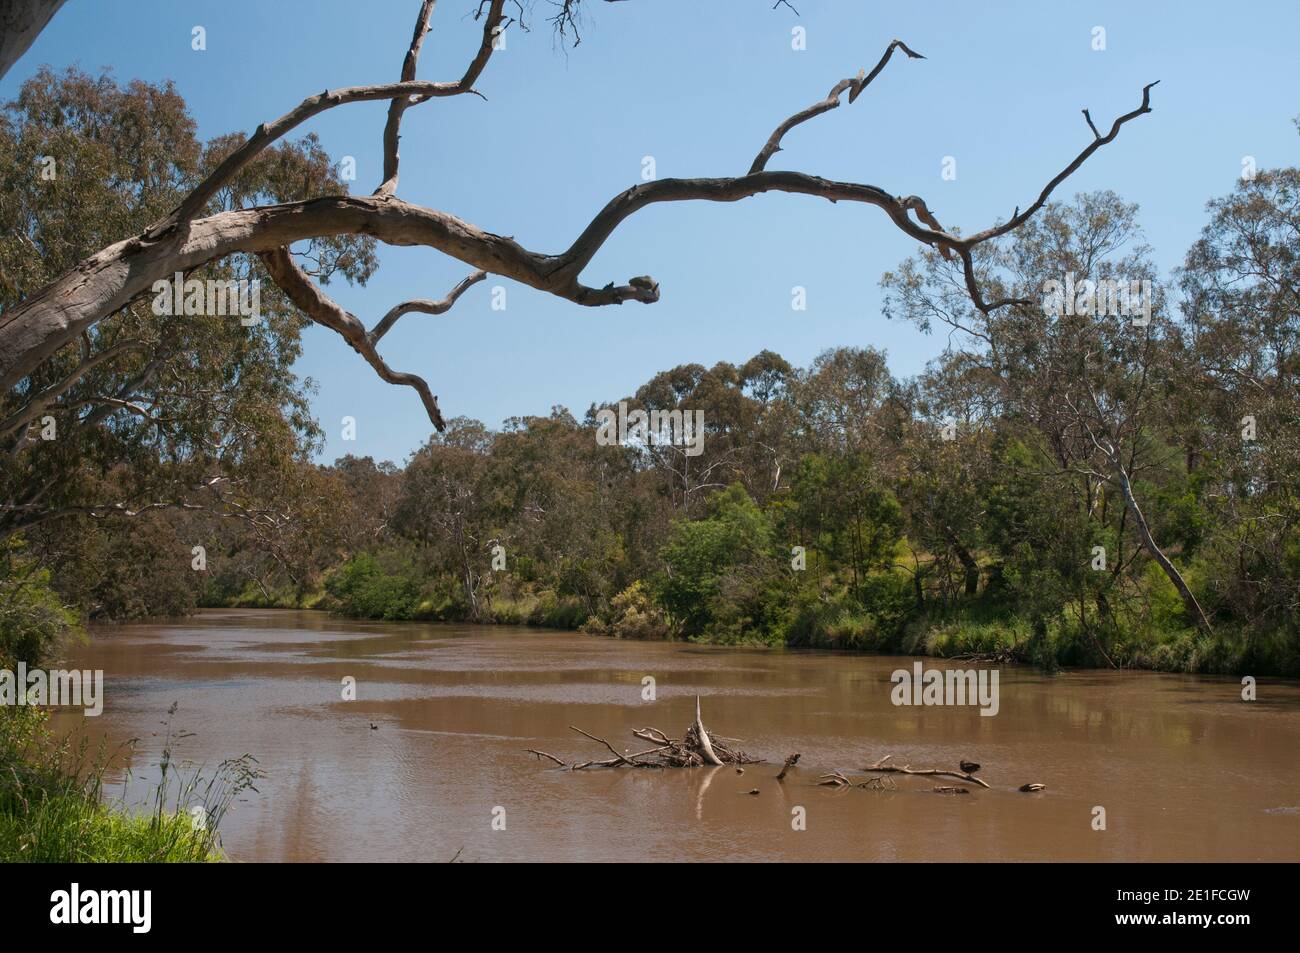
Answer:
[{"xmin": 0, "ymin": 0, "xmax": 1154, "ymax": 429}]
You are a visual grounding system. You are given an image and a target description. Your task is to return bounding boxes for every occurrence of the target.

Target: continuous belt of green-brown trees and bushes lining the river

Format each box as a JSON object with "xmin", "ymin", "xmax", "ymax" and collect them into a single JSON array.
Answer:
[{"xmin": 0, "ymin": 70, "xmax": 1300, "ymax": 675}]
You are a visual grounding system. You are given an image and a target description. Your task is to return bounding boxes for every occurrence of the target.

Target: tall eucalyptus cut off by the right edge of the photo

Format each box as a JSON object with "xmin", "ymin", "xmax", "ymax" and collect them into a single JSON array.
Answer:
[{"xmin": 1182, "ymin": 144, "xmax": 1300, "ymax": 633}]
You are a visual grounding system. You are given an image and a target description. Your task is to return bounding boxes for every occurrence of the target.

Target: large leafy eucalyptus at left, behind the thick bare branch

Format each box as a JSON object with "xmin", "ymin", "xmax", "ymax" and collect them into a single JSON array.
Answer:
[{"xmin": 0, "ymin": 69, "xmax": 374, "ymax": 615}]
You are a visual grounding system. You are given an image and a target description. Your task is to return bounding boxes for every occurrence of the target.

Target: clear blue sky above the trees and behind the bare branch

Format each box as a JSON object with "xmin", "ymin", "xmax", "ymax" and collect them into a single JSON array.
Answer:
[{"xmin": 0, "ymin": 0, "xmax": 1300, "ymax": 462}]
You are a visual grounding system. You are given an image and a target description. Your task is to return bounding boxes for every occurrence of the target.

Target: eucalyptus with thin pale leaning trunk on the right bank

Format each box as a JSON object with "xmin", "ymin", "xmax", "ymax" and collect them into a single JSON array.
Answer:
[{"xmin": 881, "ymin": 191, "xmax": 1210, "ymax": 629}]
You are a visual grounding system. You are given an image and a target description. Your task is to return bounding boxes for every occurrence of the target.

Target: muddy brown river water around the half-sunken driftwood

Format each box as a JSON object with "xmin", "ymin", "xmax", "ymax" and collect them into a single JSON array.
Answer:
[{"xmin": 48, "ymin": 610, "xmax": 1300, "ymax": 861}]
